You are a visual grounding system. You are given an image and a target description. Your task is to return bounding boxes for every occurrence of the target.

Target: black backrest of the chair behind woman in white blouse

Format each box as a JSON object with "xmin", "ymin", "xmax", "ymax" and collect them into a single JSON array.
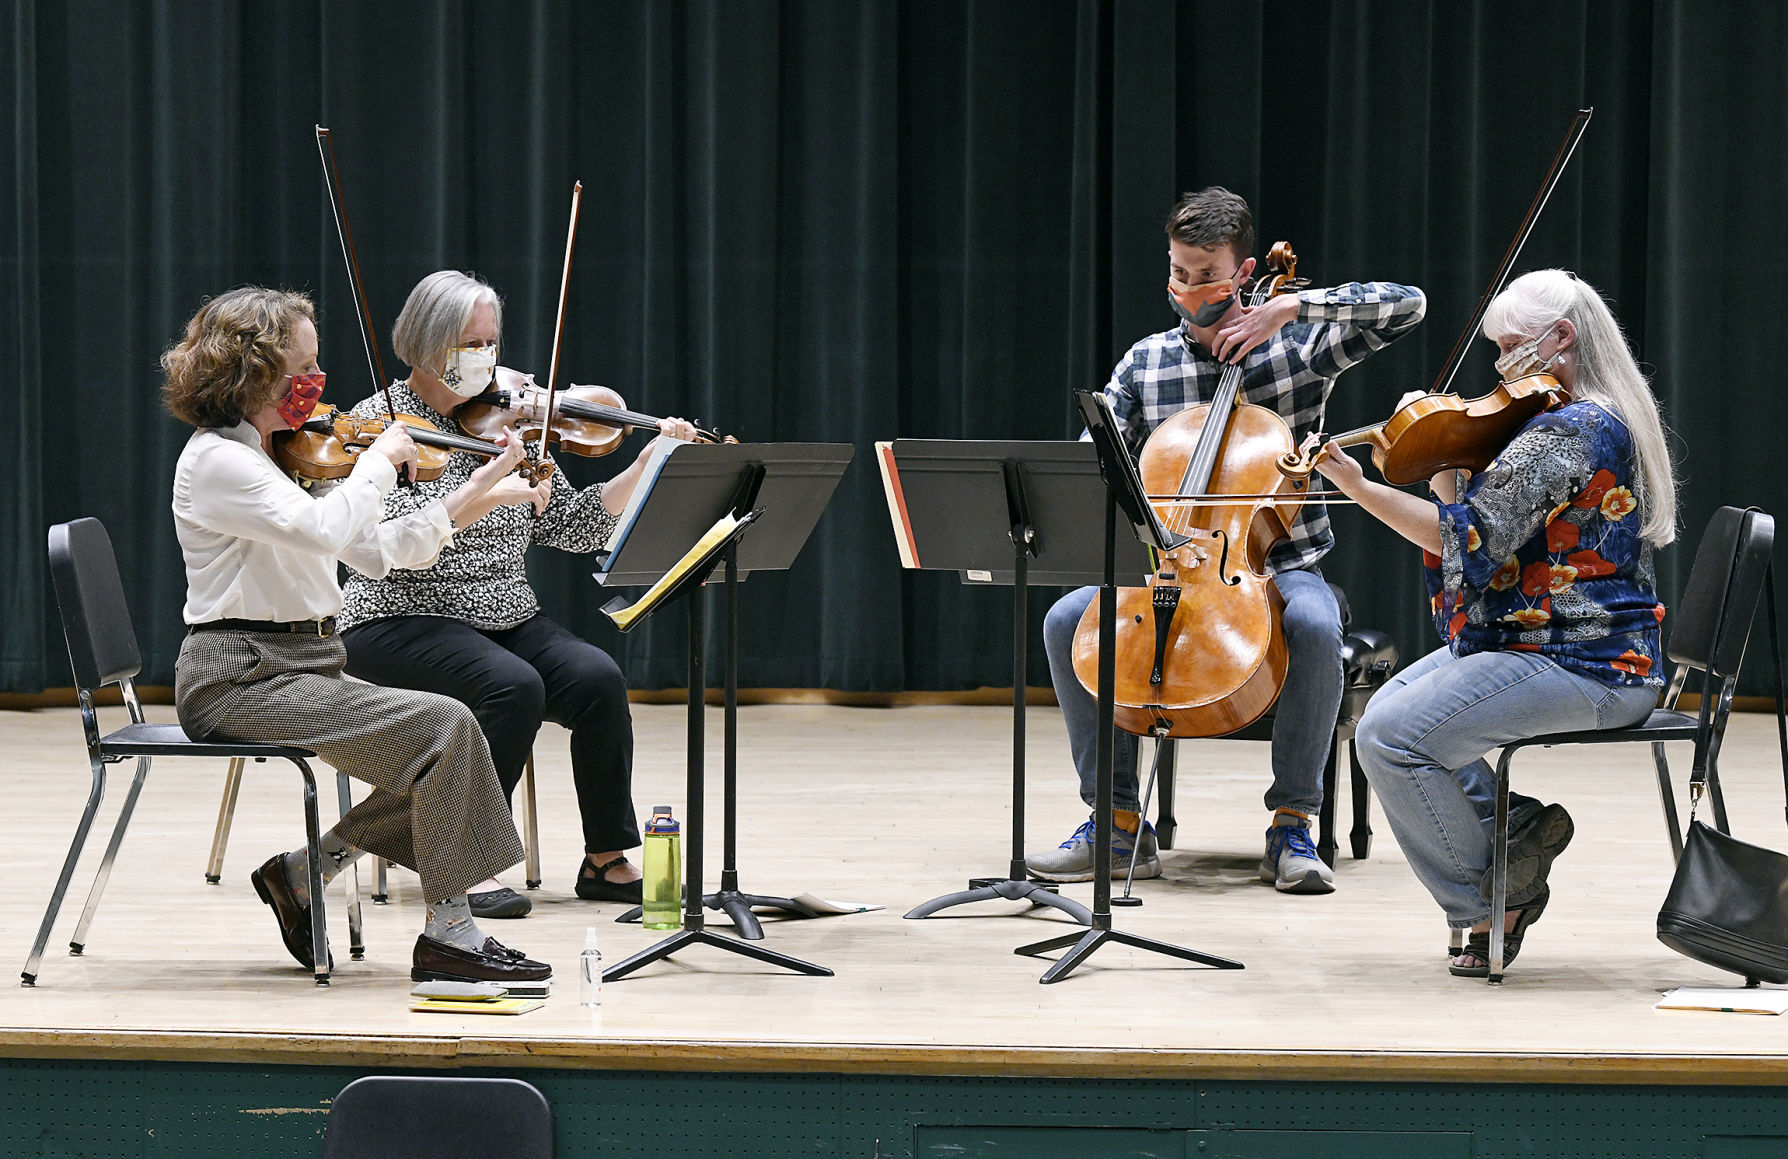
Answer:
[{"xmin": 50, "ymin": 519, "xmax": 143, "ymax": 690}]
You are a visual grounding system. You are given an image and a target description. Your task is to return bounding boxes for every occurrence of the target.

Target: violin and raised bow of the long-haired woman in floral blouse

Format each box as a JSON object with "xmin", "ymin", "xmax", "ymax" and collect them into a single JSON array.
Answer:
[{"xmin": 1280, "ymin": 109, "xmax": 1595, "ymax": 486}]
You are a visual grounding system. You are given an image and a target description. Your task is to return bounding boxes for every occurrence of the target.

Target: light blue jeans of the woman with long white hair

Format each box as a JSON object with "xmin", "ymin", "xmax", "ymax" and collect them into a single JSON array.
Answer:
[{"xmin": 1354, "ymin": 647, "xmax": 1657, "ymax": 928}]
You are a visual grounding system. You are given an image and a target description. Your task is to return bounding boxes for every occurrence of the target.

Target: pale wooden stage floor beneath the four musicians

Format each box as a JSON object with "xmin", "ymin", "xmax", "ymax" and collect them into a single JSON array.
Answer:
[{"xmin": 0, "ymin": 705, "xmax": 1788, "ymax": 1084}]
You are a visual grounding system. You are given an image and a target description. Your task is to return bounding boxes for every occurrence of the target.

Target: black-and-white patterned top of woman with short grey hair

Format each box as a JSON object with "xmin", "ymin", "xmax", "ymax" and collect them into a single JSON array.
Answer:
[{"xmin": 336, "ymin": 383, "xmax": 615, "ymax": 631}]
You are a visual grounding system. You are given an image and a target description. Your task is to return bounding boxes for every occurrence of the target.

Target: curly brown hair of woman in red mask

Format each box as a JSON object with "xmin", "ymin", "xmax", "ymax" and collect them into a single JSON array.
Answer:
[{"xmin": 161, "ymin": 286, "xmax": 316, "ymax": 427}]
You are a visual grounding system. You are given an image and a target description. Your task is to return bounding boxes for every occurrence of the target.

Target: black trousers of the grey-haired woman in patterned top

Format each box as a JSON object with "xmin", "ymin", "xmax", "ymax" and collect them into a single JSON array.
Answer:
[{"xmin": 342, "ymin": 613, "xmax": 640, "ymax": 853}]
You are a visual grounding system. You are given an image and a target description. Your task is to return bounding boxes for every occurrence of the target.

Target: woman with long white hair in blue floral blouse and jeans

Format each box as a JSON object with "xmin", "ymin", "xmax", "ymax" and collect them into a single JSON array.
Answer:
[{"xmin": 1318, "ymin": 270, "xmax": 1675, "ymax": 977}]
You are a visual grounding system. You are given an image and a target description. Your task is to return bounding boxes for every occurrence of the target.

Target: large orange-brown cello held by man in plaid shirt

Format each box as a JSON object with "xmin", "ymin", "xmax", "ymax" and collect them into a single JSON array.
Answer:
[{"xmin": 1073, "ymin": 241, "xmax": 1309, "ymax": 737}]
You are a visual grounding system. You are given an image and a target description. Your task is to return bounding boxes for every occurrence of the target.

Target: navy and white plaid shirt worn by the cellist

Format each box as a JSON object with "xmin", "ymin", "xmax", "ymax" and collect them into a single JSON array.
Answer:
[{"xmin": 1105, "ymin": 283, "xmax": 1427, "ymax": 572}]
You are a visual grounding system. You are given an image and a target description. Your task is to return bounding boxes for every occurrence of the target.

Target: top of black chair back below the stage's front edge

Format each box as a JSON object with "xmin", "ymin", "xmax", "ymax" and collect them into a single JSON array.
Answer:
[{"xmin": 324, "ymin": 1075, "xmax": 552, "ymax": 1159}]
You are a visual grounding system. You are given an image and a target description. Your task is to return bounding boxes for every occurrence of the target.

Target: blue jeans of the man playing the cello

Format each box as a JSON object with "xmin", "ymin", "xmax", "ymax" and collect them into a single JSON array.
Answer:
[{"xmin": 1042, "ymin": 567, "xmax": 1341, "ymax": 816}]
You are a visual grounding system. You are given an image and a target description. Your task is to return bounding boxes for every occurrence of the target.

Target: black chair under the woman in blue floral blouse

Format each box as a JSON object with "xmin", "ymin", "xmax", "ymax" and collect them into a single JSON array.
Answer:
[{"xmin": 1488, "ymin": 508, "xmax": 1775, "ymax": 984}]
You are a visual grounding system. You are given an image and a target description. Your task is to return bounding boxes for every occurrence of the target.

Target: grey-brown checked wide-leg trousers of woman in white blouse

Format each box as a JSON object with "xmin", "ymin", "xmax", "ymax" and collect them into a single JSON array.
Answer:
[{"xmin": 173, "ymin": 631, "xmax": 522, "ymax": 900}]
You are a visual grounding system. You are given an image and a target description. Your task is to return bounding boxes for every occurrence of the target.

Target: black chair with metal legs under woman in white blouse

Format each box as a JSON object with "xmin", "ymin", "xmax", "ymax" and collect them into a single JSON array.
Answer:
[{"xmin": 20, "ymin": 519, "xmax": 365, "ymax": 986}]
